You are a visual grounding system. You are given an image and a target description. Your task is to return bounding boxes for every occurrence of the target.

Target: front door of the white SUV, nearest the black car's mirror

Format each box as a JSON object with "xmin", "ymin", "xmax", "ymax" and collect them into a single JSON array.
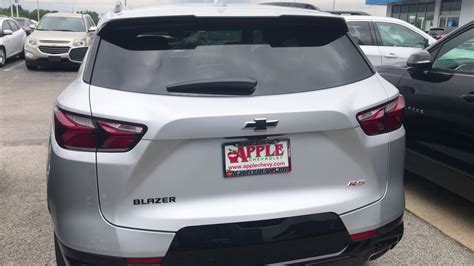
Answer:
[{"xmin": 374, "ymin": 22, "xmax": 428, "ymax": 65}]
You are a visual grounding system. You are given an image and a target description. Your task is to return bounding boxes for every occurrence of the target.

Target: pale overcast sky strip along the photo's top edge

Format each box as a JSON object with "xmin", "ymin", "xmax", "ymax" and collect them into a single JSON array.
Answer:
[{"xmin": 0, "ymin": 0, "xmax": 386, "ymax": 16}]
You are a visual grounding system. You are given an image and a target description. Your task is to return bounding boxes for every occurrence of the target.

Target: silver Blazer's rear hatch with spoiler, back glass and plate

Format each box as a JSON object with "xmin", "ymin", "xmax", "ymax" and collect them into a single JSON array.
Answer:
[{"xmin": 89, "ymin": 16, "xmax": 388, "ymax": 231}]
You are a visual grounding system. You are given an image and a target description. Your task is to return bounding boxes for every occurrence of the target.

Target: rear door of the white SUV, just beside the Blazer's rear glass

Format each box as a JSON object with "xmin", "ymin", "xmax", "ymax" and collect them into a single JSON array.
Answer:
[{"xmin": 347, "ymin": 21, "xmax": 382, "ymax": 66}]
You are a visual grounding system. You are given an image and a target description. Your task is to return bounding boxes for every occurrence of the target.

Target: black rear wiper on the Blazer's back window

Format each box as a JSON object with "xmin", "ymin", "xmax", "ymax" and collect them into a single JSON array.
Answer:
[{"xmin": 166, "ymin": 78, "xmax": 257, "ymax": 95}]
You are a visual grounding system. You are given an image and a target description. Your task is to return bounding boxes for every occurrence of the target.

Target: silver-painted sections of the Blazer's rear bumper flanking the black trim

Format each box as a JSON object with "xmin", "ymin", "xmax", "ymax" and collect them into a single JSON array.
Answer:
[{"xmin": 48, "ymin": 130, "xmax": 405, "ymax": 258}]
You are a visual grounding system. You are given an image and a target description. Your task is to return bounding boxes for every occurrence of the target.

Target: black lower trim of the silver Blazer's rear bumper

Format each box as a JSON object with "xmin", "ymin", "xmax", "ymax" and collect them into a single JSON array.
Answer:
[{"xmin": 55, "ymin": 213, "xmax": 403, "ymax": 266}]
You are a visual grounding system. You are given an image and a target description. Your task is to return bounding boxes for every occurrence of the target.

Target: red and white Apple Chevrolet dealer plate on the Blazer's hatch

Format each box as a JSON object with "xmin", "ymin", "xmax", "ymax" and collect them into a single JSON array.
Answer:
[{"xmin": 222, "ymin": 139, "xmax": 291, "ymax": 177}]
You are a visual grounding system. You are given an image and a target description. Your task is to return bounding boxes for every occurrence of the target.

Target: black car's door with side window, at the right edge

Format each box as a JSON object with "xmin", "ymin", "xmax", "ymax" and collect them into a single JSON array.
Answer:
[{"xmin": 399, "ymin": 26, "xmax": 474, "ymax": 175}]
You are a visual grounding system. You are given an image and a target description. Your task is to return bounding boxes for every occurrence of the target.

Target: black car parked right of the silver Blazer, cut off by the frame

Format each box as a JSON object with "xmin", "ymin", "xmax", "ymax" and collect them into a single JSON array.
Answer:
[{"xmin": 377, "ymin": 21, "xmax": 474, "ymax": 202}]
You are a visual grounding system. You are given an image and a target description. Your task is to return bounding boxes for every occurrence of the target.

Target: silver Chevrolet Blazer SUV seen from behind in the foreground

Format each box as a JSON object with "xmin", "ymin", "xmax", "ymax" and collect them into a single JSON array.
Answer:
[{"xmin": 48, "ymin": 5, "xmax": 405, "ymax": 265}]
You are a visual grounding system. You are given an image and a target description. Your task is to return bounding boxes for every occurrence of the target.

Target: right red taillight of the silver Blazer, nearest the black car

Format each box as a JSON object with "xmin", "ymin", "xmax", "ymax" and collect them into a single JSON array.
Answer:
[{"xmin": 357, "ymin": 96, "xmax": 405, "ymax": 136}]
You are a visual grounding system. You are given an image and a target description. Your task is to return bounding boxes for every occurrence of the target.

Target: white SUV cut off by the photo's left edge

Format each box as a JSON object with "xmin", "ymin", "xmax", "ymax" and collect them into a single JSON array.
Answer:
[{"xmin": 0, "ymin": 17, "xmax": 26, "ymax": 67}]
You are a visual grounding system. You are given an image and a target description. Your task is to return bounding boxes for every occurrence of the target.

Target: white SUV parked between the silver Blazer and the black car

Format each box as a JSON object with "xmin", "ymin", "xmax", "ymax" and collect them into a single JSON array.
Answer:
[{"xmin": 344, "ymin": 16, "xmax": 436, "ymax": 66}]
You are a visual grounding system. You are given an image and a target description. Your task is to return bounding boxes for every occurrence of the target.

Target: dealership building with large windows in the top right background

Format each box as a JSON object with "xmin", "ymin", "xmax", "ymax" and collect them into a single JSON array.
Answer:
[{"xmin": 366, "ymin": 0, "xmax": 474, "ymax": 31}]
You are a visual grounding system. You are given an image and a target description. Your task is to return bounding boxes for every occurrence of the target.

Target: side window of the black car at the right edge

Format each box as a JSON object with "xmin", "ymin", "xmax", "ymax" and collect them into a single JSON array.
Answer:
[{"xmin": 433, "ymin": 28, "xmax": 474, "ymax": 73}]
